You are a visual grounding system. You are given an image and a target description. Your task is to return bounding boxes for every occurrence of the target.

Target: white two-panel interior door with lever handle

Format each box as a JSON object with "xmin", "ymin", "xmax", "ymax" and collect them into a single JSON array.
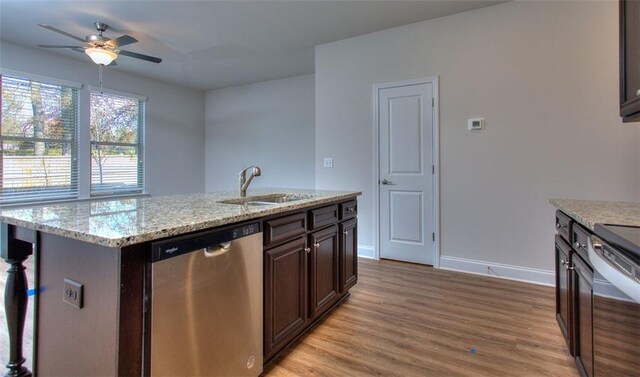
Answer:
[{"xmin": 378, "ymin": 83, "xmax": 434, "ymax": 265}]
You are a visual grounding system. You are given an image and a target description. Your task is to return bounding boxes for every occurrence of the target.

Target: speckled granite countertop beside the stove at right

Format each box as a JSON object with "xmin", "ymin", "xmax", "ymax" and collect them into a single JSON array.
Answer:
[{"xmin": 550, "ymin": 199, "xmax": 640, "ymax": 230}]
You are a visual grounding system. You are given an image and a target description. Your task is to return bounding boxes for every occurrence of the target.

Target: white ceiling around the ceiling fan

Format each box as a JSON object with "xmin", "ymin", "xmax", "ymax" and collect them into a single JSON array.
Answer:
[{"xmin": 0, "ymin": 0, "xmax": 501, "ymax": 90}]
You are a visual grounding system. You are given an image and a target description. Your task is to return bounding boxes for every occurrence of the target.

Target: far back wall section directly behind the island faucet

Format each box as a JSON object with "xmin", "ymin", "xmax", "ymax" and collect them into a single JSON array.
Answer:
[{"xmin": 205, "ymin": 75, "xmax": 315, "ymax": 191}]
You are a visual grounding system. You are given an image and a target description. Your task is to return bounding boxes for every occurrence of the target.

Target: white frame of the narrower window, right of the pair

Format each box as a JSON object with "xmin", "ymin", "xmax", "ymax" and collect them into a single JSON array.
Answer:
[{"xmin": 87, "ymin": 85, "xmax": 147, "ymax": 198}]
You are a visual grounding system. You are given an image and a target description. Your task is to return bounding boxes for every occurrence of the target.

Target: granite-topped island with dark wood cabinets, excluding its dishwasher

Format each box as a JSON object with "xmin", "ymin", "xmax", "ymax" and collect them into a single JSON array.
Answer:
[{"xmin": 0, "ymin": 189, "xmax": 360, "ymax": 376}]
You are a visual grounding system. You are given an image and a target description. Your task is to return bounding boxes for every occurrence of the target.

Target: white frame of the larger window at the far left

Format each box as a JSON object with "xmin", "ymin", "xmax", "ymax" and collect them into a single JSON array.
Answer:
[{"xmin": 0, "ymin": 68, "xmax": 83, "ymax": 208}]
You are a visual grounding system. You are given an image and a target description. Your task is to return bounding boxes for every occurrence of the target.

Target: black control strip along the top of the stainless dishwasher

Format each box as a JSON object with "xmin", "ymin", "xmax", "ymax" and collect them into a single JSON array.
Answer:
[{"xmin": 150, "ymin": 222, "xmax": 260, "ymax": 263}]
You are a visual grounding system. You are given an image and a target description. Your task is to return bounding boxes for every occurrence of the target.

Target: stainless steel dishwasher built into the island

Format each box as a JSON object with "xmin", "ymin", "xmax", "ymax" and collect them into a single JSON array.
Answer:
[{"xmin": 145, "ymin": 222, "xmax": 263, "ymax": 376}]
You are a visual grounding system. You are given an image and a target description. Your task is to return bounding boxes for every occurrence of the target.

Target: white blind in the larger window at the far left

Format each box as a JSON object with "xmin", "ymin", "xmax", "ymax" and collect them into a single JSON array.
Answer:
[{"xmin": 0, "ymin": 75, "xmax": 78, "ymax": 205}]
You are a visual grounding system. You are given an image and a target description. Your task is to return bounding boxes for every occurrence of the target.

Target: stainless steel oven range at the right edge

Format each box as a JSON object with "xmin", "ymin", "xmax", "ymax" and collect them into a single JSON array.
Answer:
[{"xmin": 588, "ymin": 224, "xmax": 640, "ymax": 377}]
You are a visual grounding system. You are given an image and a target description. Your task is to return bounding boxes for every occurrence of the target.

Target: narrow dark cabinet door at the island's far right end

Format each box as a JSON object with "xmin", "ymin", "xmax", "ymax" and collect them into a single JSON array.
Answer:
[{"xmin": 339, "ymin": 219, "xmax": 358, "ymax": 294}]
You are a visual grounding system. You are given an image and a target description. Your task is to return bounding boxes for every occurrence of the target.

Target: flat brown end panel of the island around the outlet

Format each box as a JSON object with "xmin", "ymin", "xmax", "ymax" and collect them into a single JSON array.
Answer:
[{"xmin": 36, "ymin": 233, "xmax": 120, "ymax": 376}]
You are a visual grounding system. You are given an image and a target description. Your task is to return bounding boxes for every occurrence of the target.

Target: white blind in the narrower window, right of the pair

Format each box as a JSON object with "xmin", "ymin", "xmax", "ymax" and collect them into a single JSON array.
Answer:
[{"xmin": 90, "ymin": 91, "xmax": 144, "ymax": 196}]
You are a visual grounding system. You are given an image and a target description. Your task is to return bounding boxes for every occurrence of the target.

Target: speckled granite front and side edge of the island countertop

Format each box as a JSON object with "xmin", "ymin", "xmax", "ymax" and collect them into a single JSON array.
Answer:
[{"xmin": 0, "ymin": 191, "xmax": 362, "ymax": 248}]
